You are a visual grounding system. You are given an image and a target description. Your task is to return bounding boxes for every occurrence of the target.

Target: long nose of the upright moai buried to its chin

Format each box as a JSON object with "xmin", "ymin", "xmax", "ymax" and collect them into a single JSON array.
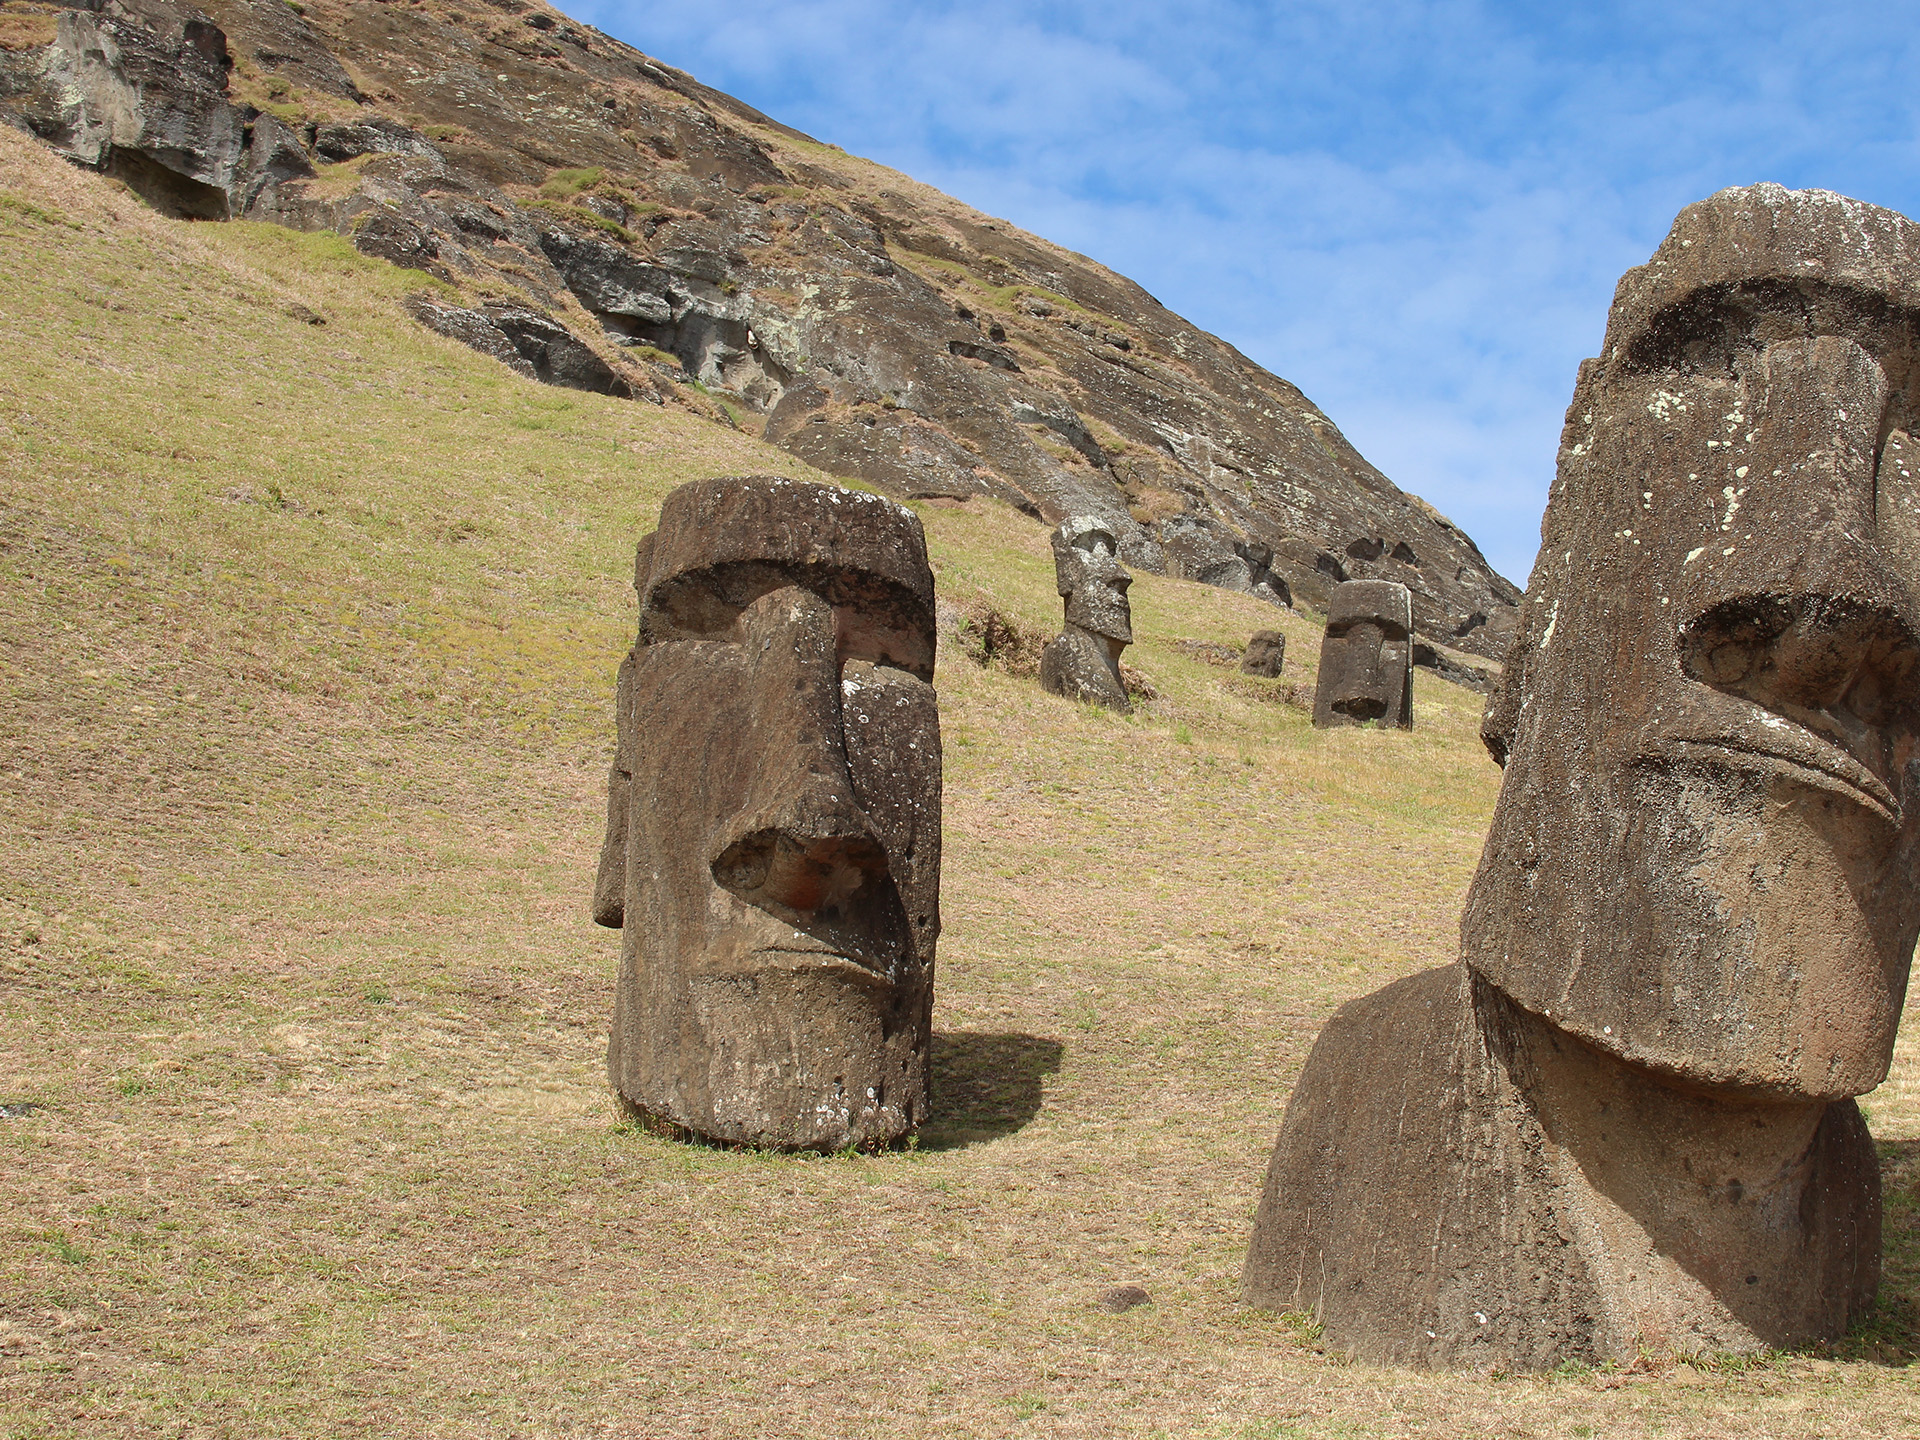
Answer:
[{"xmin": 710, "ymin": 589, "xmax": 889, "ymax": 922}]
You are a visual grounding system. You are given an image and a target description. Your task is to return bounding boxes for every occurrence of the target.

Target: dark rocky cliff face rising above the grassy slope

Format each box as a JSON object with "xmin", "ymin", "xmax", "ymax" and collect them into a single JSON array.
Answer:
[{"xmin": 0, "ymin": 0, "xmax": 1519, "ymax": 657}]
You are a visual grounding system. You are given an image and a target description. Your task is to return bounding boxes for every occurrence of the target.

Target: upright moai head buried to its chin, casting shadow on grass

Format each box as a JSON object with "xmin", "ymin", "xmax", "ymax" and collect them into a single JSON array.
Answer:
[{"xmin": 593, "ymin": 476, "xmax": 941, "ymax": 1150}]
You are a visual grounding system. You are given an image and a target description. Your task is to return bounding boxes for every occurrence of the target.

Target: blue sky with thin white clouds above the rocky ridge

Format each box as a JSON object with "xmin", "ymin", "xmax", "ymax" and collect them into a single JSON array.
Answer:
[{"xmin": 566, "ymin": 0, "xmax": 1920, "ymax": 582}]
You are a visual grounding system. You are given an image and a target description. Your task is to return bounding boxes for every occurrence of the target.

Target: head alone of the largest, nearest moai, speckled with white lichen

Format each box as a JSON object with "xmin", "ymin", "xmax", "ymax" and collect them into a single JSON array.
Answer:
[{"xmin": 1461, "ymin": 184, "xmax": 1920, "ymax": 1100}]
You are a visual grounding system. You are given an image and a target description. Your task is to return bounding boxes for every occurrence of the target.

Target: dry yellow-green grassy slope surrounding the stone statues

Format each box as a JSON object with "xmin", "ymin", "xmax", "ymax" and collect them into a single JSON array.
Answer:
[{"xmin": 0, "ymin": 129, "xmax": 1920, "ymax": 1436}]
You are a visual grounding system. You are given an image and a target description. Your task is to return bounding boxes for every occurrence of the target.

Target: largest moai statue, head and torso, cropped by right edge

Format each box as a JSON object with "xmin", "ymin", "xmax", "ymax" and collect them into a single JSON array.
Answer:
[{"xmin": 1246, "ymin": 184, "xmax": 1920, "ymax": 1369}]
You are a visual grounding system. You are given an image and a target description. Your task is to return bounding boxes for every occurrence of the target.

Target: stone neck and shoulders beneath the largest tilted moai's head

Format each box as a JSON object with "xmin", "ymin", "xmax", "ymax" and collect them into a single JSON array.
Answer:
[{"xmin": 1246, "ymin": 966, "xmax": 1880, "ymax": 1369}]
